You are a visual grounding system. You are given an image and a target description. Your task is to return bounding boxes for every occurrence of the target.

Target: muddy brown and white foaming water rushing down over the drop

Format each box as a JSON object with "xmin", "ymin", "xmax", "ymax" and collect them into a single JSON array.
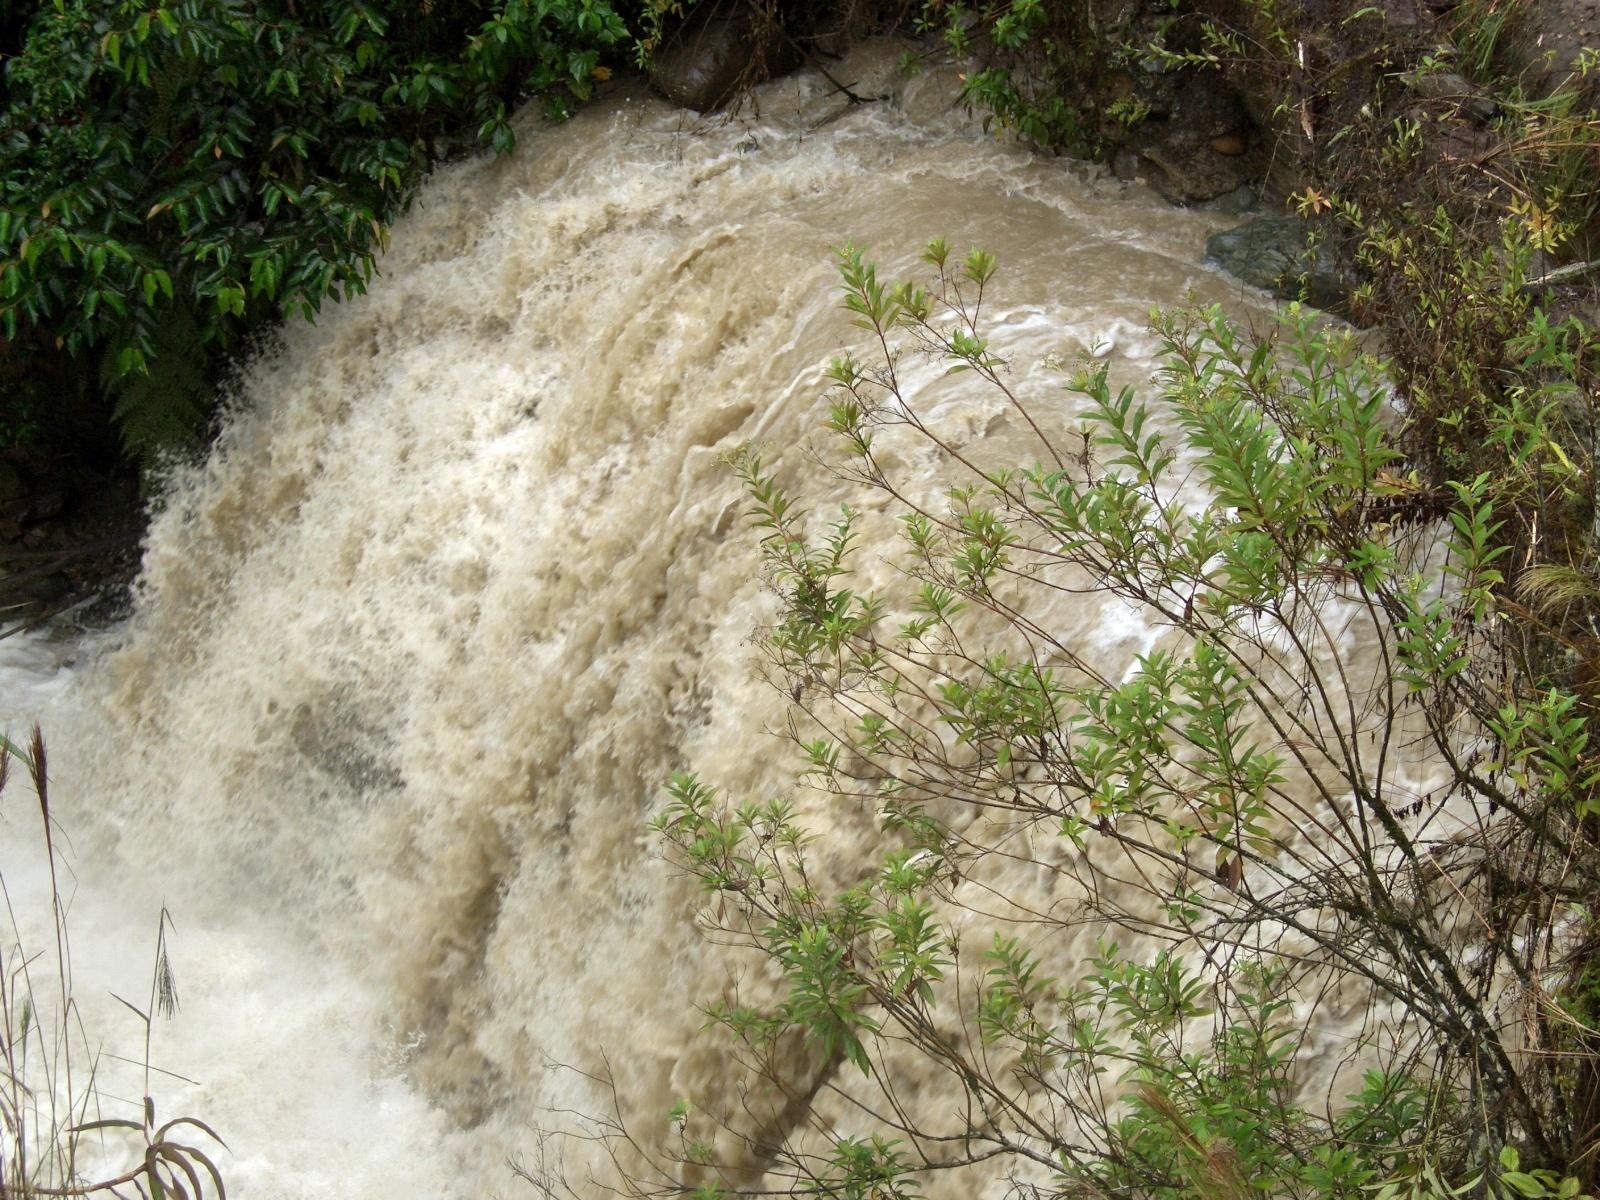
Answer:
[{"xmin": 6, "ymin": 42, "xmax": 1280, "ymax": 1200}]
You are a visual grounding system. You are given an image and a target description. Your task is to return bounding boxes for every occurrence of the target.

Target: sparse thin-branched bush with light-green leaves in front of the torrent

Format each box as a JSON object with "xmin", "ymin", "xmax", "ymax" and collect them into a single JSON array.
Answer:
[{"xmin": 608, "ymin": 243, "xmax": 1600, "ymax": 1200}]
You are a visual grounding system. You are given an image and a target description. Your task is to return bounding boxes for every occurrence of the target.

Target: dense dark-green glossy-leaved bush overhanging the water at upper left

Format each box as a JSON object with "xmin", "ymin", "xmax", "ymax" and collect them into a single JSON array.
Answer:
[{"xmin": 0, "ymin": 0, "xmax": 627, "ymax": 453}]
